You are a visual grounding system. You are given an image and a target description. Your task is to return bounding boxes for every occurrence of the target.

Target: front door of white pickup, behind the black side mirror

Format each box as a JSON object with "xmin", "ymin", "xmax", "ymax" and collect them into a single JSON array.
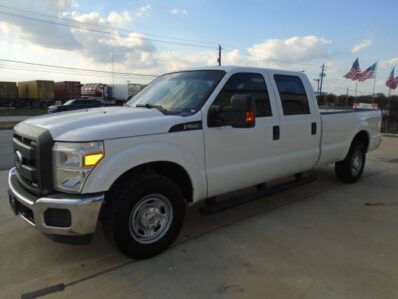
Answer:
[{"xmin": 203, "ymin": 72, "xmax": 280, "ymax": 197}]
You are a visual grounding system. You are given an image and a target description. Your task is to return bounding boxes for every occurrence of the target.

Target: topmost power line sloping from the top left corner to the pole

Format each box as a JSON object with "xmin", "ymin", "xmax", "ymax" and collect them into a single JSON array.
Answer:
[{"xmin": 0, "ymin": 4, "xmax": 217, "ymax": 45}]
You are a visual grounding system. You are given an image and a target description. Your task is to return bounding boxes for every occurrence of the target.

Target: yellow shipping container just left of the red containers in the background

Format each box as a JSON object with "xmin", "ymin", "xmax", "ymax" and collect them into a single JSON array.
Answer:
[{"xmin": 18, "ymin": 80, "xmax": 54, "ymax": 100}]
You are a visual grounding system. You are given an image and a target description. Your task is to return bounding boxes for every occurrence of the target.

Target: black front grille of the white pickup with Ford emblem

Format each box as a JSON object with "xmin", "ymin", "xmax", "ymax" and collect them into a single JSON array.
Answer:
[{"xmin": 13, "ymin": 123, "xmax": 53, "ymax": 196}]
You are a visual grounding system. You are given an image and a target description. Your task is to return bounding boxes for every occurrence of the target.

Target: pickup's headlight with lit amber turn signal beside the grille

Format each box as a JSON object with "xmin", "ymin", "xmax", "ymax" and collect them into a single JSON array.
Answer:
[{"xmin": 53, "ymin": 142, "xmax": 105, "ymax": 193}]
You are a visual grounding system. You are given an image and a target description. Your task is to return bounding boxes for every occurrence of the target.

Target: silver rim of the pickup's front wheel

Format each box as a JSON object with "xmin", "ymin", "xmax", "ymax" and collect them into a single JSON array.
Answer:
[{"xmin": 129, "ymin": 194, "xmax": 173, "ymax": 244}]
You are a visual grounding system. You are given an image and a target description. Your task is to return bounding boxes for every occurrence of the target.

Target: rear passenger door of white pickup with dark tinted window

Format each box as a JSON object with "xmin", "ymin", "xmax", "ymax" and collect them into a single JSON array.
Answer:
[{"xmin": 269, "ymin": 71, "xmax": 321, "ymax": 175}]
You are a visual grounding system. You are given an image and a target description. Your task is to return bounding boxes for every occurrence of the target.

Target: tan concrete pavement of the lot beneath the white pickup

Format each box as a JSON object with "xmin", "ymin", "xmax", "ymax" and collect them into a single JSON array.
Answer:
[{"xmin": 0, "ymin": 137, "xmax": 398, "ymax": 298}]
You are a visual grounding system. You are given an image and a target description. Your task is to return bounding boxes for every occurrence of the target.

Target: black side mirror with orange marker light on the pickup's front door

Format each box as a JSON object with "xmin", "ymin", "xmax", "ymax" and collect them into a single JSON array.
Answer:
[{"xmin": 210, "ymin": 95, "xmax": 256, "ymax": 128}]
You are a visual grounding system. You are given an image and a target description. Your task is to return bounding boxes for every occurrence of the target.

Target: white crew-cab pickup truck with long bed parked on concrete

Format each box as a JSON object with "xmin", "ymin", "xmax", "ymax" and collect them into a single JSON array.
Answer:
[{"xmin": 9, "ymin": 67, "xmax": 381, "ymax": 258}]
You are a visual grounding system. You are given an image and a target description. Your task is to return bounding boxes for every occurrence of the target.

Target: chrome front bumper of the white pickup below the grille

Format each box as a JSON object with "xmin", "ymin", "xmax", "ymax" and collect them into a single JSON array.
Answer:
[{"xmin": 8, "ymin": 168, "xmax": 104, "ymax": 236}]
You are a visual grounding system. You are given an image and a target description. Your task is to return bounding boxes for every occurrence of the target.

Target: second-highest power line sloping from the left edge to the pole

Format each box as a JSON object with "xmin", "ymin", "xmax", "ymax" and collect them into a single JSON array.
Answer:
[{"xmin": 0, "ymin": 11, "xmax": 218, "ymax": 49}]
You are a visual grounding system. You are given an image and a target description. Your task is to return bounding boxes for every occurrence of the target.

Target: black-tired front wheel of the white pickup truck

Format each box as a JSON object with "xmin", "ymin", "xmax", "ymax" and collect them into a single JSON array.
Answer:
[{"xmin": 102, "ymin": 172, "xmax": 185, "ymax": 259}]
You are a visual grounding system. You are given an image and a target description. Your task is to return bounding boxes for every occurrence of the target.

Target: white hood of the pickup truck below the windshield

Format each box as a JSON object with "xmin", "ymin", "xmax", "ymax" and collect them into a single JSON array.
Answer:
[{"xmin": 23, "ymin": 107, "xmax": 183, "ymax": 141}]
